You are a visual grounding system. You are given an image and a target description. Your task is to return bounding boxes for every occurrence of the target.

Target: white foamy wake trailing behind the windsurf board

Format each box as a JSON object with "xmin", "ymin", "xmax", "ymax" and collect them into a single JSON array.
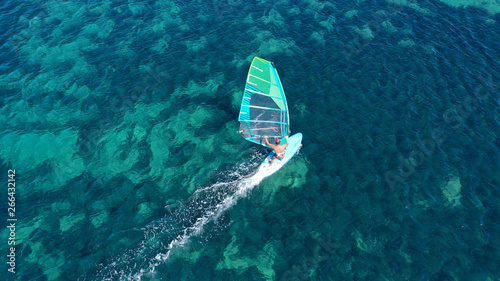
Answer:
[{"xmin": 94, "ymin": 167, "xmax": 263, "ymax": 280}]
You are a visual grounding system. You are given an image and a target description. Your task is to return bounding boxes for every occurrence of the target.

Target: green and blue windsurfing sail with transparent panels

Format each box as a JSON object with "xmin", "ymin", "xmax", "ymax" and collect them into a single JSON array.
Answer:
[{"xmin": 238, "ymin": 57, "xmax": 290, "ymax": 146}]
